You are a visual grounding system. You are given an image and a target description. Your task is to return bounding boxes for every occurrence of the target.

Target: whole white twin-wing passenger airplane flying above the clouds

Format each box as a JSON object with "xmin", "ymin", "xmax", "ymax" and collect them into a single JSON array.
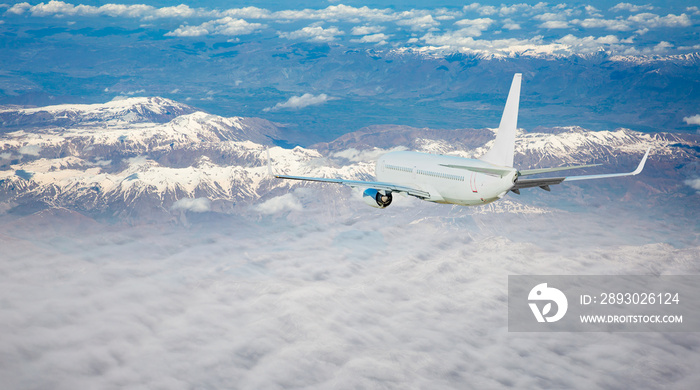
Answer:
[{"xmin": 267, "ymin": 73, "xmax": 651, "ymax": 209}]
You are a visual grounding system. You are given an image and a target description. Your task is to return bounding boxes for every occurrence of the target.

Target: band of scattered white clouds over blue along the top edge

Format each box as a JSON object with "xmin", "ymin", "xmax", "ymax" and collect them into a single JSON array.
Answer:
[{"xmin": 5, "ymin": 1, "xmax": 700, "ymax": 55}]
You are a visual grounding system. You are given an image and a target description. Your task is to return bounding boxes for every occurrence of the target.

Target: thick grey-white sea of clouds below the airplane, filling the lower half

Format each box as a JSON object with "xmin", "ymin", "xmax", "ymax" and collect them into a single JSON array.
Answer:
[{"xmin": 0, "ymin": 190, "xmax": 700, "ymax": 389}]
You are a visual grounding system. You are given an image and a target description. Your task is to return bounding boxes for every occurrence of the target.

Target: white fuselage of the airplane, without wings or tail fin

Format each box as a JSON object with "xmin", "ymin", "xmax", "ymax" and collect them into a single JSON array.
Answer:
[{"xmin": 375, "ymin": 152, "xmax": 517, "ymax": 206}]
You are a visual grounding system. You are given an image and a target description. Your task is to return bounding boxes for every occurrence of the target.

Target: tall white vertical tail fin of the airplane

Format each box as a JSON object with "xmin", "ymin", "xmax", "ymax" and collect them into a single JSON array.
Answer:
[{"xmin": 479, "ymin": 73, "xmax": 523, "ymax": 167}]
